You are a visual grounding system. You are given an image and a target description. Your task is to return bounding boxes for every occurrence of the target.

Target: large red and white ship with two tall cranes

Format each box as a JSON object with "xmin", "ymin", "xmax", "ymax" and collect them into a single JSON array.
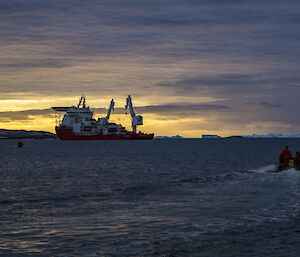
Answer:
[{"xmin": 52, "ymin": 95, "xmax": 154, "ymax": 140}]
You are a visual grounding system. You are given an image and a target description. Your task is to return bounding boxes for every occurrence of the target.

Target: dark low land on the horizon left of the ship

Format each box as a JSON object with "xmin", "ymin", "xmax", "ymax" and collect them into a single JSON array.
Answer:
[{"xmin": 0, "ymin": 129, "xmax": 56, "ymax": 139}]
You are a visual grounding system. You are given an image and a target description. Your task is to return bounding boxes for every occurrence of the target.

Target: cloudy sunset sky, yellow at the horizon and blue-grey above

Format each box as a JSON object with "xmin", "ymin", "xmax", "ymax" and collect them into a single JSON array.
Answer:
[{"xmin": 0, "ymin": 0, "xmax": 300, "ymax": 137}]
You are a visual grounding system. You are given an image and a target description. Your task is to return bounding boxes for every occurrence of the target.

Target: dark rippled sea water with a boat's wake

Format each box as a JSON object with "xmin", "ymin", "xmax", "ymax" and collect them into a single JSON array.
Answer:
[{"xmin": 0, "ymin": 139, "xmax": 300, "ymax": 256}]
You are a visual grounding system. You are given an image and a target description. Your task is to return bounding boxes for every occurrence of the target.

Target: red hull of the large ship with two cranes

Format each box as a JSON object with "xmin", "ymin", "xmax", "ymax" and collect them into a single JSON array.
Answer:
[{"xmin": 55, "ymin": 127, "xmax": 154, "ymax": 140}]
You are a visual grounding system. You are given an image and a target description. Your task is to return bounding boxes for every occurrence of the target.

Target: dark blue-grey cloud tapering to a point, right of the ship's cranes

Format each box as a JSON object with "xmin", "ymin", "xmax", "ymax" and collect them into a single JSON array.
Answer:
[{"xmin": 155, "ymin": 73, "xmax": 300, "ymax": 108}]
